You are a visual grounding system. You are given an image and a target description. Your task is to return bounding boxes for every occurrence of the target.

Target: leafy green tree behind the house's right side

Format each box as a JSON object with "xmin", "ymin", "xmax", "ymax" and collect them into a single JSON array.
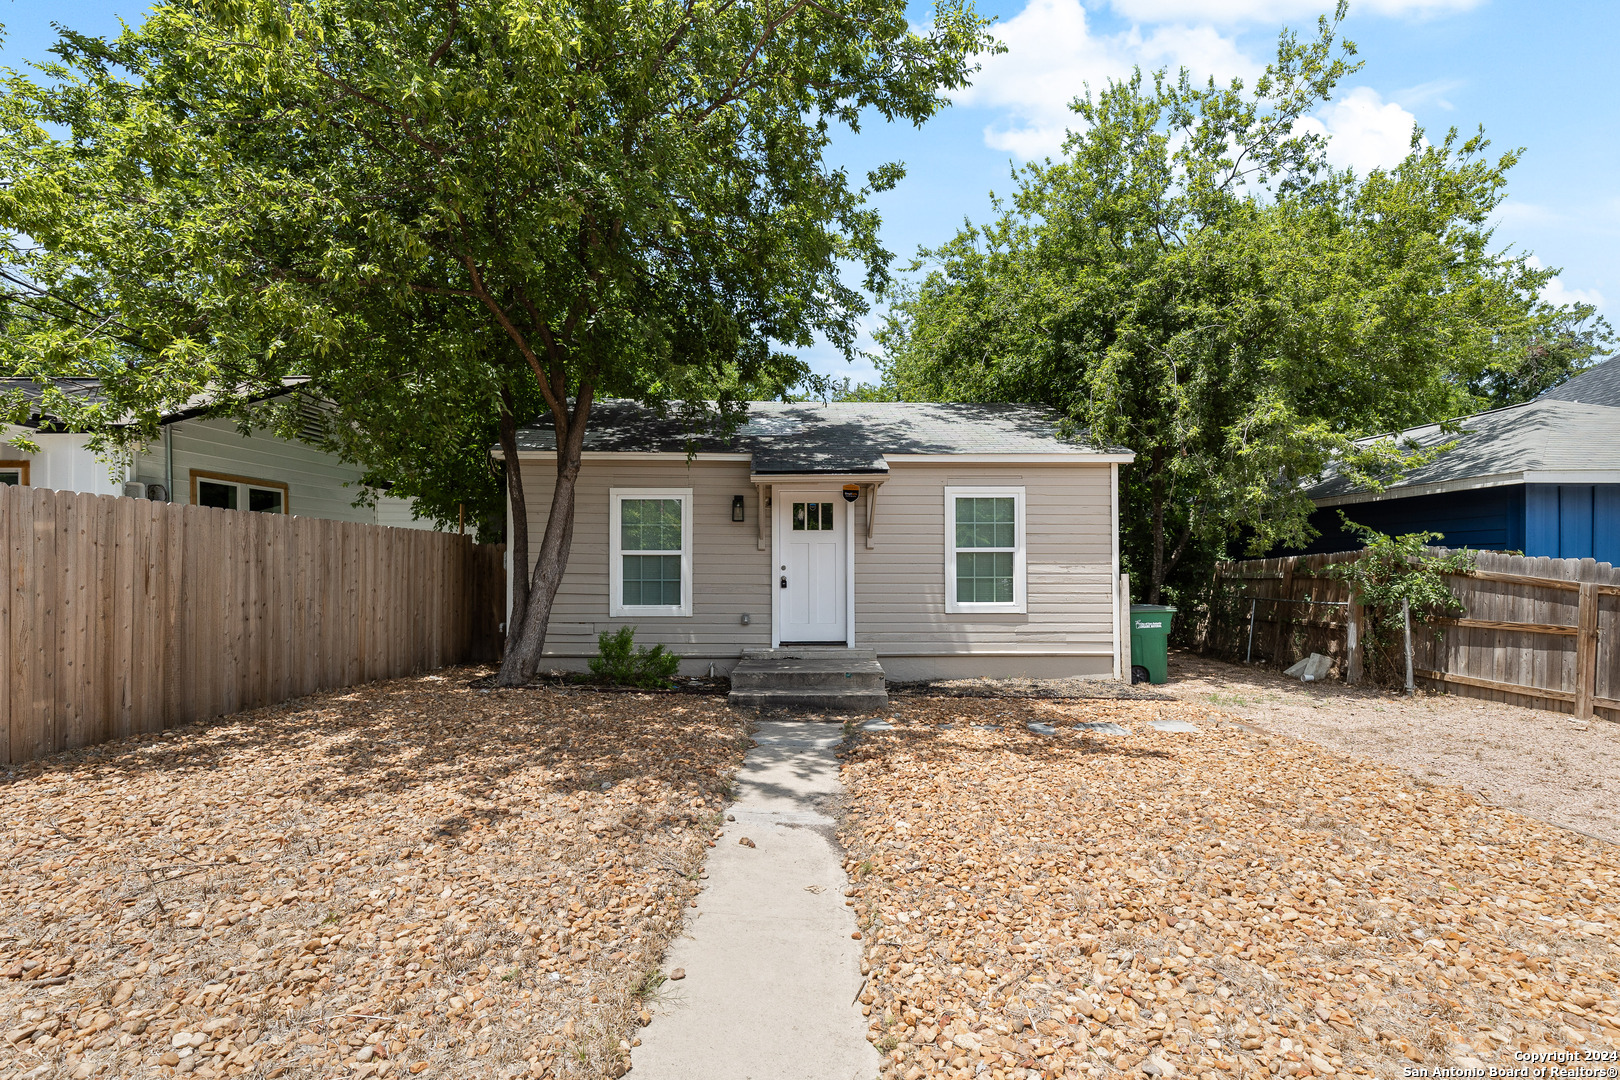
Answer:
[{"xmin": 880, "ymin": 6, "xmax": 1597, "ymax": 602}]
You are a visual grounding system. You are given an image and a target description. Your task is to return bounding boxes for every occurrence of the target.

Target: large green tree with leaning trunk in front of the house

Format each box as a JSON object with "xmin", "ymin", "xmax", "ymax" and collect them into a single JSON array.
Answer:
[{"xmin": 0, "ymin": 0, "xmax": 988, "ymax": 683}]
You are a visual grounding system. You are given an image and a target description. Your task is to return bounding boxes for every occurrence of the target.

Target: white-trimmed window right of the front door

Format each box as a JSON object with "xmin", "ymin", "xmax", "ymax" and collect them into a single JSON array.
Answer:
[{"xmin": 944, "ymin": 487, "xmax": 1027, "ymax": 614}]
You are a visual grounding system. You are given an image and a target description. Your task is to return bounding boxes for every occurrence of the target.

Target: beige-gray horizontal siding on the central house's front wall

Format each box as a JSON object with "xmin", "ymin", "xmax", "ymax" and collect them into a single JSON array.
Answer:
[{"xmin": 523, "ymin": 455, "xmax": 1116, "ymax": 677}]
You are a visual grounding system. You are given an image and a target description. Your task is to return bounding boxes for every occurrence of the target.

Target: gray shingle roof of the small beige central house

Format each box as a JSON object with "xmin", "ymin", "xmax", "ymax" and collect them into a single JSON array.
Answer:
[{"xmin": 518, "ymin": 400, "xmax": 1123, "ymax": 473}]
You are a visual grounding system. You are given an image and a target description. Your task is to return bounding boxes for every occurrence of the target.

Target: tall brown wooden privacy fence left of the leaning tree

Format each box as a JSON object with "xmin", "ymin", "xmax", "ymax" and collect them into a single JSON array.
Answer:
[{"xmin": 0, "ymin": 486, "xmax": 504, "ymax": 763}]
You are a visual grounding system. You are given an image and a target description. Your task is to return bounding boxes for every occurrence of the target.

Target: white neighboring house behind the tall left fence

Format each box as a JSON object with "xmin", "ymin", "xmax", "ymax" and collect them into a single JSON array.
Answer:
[{"xmin": 0, "ymin": 379, "xmax": 433, "ymax": 529}]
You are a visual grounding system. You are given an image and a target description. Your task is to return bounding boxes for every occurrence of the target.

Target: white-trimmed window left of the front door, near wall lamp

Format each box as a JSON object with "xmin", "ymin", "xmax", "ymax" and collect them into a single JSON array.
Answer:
[{"xmin": 608, "ymin": 487, "xmax": 692, "ymax": 619}]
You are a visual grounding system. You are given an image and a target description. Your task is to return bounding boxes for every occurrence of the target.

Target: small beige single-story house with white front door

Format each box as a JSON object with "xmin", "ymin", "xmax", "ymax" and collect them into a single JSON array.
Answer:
[{"xmin": 497, "ymin": 400, "xmax": 1132, "ymax": 680}]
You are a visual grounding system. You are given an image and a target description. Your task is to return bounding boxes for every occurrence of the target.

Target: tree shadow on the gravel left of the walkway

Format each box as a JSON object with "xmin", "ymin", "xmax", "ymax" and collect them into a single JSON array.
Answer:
[{"xmin": 0, "ymin": 669, "xmax": 744, "ymax": 816}]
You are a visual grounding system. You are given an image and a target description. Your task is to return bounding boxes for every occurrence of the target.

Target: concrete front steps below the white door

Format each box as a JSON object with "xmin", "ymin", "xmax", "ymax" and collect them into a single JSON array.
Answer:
[{"xmin": 729, "ymin": 648, "xmax": 889, "ymax": 712}]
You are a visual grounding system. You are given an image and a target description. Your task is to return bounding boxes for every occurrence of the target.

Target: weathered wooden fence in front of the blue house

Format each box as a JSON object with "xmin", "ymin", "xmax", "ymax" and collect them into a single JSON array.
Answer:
[{"xmin": 1205, "ymin": 552, "xmax": 1620, "ymax": 719}]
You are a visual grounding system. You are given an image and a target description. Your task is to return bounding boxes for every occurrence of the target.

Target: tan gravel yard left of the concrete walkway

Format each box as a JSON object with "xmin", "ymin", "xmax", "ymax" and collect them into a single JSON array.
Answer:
[{"xmin": 0, "ymin": 670, "xmax": 747, "ymax": 1080}]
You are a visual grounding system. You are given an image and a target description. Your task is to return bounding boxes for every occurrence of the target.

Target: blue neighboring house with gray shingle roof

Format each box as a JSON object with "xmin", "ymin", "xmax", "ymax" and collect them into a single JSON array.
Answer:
[{"xmin": 1302, "ymin": 356, "xmax": 1620, "ymax": 565}]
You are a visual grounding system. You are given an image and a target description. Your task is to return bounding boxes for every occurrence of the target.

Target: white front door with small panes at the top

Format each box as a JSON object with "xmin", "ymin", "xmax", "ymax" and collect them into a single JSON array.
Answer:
[{"xmin": 771, "ymin": 487, "xmax": 849, "ymax": 644}]
